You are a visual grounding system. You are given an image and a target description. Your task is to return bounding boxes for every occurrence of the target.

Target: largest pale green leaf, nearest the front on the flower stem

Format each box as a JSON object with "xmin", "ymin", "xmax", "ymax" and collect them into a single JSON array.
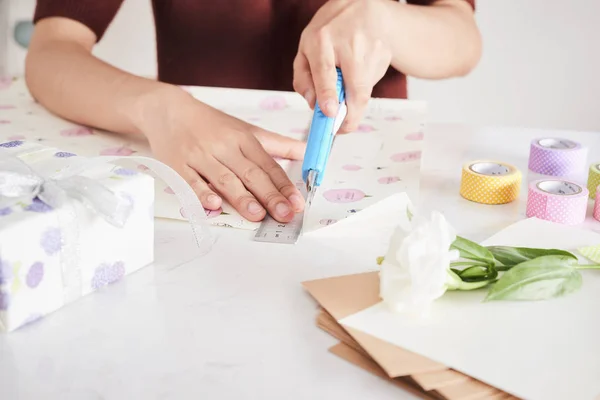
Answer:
[{"xmin": 485, "ymin": 255, "xmax": 582, "ymax": 301}]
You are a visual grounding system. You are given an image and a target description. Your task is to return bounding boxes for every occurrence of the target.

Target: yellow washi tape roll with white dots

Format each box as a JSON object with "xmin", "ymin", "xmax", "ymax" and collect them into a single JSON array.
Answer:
[{"xmin": 460, "ymin": 160, "xmax": 521, "ymax": 204}]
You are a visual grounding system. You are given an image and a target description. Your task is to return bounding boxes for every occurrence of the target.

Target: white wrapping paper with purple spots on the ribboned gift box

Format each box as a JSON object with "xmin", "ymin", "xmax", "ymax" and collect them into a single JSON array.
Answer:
[{"xmin": 0, "ymin": 141, "xmax": 154, "ymax": 331}]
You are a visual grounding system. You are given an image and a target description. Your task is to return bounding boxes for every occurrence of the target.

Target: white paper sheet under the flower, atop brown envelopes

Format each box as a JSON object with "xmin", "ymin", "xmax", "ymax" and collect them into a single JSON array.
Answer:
[{"xmin": 339, "ymin": 219, "xmax": 600, "ymax": 400}]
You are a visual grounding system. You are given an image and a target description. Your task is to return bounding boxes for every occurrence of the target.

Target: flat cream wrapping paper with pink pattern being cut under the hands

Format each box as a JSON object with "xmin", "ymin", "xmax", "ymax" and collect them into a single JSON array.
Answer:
[{"xmin": 0, "ymin": 78, "xmax": 426, "ymax": 232}]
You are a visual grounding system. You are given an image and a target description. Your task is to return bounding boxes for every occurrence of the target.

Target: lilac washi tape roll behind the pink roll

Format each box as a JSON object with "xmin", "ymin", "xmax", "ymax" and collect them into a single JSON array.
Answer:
[{"xmin": 529, "ymin": 138, "xmax": 588, "ymax": 177}]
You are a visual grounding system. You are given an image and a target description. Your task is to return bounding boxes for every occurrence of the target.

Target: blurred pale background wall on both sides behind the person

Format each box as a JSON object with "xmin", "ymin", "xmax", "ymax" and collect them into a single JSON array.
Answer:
[{"xmin": 0, "ymin": 0, "xmax": 600, "ymax": 131}]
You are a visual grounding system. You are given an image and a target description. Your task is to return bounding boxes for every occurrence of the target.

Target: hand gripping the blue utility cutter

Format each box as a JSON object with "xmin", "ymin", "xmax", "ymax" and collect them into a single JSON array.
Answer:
[{"xmin": 294, "ymin": 0, "xmax": 392, "ymax": 133}]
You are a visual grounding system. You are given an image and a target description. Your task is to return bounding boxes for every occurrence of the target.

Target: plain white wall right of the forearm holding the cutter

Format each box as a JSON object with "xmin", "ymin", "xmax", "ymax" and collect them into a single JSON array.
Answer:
[{"xmin": 410, "ymin": 0, "xmax": 600, "ymax": 131}]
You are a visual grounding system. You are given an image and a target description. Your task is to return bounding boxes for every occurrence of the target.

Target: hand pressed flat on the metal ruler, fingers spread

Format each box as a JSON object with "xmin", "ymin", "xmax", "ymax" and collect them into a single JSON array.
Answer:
[{"xmin": 140, "ymin": 87, "xmax": 305, "ymax": 223}]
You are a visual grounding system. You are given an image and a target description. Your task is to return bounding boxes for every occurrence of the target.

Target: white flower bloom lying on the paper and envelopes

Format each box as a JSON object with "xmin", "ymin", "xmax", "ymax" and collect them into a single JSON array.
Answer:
[{"xmin": 380, "ymin": 211, "xmax": 460, "ymax": 316}]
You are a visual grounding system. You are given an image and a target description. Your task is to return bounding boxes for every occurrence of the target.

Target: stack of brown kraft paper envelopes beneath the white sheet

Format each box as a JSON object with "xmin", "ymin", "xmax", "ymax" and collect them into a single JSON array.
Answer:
[{"xmin": 303, "ymin": 272, "xmax": 514, "ymax": 400}]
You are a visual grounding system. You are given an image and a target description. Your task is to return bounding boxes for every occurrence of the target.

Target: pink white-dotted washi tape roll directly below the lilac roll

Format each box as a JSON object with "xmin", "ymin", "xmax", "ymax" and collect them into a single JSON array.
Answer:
[{"xmin": 526, "ymin": 179, "xmax": 589, "ymax": 225}]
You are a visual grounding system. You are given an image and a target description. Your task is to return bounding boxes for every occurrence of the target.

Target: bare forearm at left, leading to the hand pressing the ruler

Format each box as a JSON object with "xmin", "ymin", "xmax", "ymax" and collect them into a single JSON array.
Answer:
[{"xmin": 26, "ymin": 34, "xmax": 186, "ymax": 134}]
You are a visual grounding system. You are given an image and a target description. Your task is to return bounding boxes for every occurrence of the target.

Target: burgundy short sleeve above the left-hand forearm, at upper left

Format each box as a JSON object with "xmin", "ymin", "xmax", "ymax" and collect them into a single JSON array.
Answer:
[{"xmin": 33, "ymin": 0, "xmax": 123, "ymax": 42}]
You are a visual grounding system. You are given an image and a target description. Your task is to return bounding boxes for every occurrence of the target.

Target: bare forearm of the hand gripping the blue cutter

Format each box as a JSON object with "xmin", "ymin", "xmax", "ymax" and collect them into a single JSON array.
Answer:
[{"xmin": 385, "ymin": 0, "xmax": 481, "ymax": 79}]
